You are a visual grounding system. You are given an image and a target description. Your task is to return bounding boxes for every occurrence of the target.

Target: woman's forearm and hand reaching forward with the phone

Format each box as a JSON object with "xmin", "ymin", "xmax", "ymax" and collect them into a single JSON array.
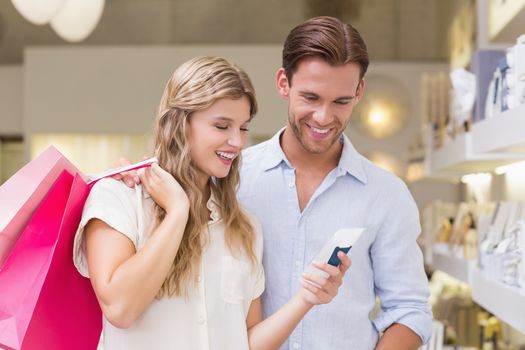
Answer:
[{"xmin": 246, "ymin": 252, "xmax": 351, "ymax": 350}]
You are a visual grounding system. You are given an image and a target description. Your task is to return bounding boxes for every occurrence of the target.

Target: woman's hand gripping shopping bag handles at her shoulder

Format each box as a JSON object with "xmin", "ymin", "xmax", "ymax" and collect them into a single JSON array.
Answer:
[{"xmin": 138, "ymin": 163, "xmax": 190, "ymax": 214}]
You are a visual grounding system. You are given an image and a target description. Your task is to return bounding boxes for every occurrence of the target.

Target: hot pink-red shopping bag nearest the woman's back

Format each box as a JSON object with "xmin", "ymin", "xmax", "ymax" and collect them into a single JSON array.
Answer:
[{"xmin": 0, "ymin": 170, "xmax": 102, "ymax": 350}]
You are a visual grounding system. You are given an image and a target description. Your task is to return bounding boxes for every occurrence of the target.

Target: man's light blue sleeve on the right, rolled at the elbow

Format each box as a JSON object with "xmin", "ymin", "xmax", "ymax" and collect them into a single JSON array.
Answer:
[{"xmin": 371, "ymin": 185, "xmax": 432, "ymax": 344}]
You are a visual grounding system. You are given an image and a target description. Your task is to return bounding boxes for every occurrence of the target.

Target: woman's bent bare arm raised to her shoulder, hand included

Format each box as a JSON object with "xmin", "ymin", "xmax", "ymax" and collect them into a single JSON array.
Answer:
[{"xmin": 85, "ymin": 165, "xmax": 189, "ymax": 328}]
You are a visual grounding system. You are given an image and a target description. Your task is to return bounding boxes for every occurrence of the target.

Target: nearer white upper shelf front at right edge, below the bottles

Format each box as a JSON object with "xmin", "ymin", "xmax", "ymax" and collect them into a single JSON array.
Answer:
[{"xmin": 472, "ymin": 104, "xmax": 525, "ymax": 154}]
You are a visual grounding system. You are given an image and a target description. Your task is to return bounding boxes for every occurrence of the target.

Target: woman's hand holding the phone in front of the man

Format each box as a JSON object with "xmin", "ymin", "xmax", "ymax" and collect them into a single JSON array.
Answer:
[{"xmin": 298, "ymin": 252, "xmax": 352, "ymax": 305}]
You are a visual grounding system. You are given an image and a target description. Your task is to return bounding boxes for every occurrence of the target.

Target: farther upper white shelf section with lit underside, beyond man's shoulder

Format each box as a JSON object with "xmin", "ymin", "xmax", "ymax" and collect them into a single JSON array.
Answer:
[{"xmin": 430, "ymin": 132, "xmax": 518, "ymax": 174}]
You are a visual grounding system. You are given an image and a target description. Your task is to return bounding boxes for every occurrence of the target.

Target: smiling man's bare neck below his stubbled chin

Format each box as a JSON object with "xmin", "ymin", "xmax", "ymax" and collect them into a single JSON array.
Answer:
[{"xmin": 280, "ymin": 126, "xmax": 343, "ymax": 172}]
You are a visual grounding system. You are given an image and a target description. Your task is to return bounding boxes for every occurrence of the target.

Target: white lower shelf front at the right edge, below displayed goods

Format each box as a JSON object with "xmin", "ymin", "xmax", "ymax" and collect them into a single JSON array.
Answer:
[{"xmin": 471, "ymin": 268, "xmax": 525, "ymax": 333}]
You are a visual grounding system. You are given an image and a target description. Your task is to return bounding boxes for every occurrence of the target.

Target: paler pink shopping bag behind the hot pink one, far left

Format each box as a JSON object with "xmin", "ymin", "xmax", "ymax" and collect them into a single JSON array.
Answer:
[{"xmin": 0, "ymin": 146, "xmax": 79, "ymax": 270}]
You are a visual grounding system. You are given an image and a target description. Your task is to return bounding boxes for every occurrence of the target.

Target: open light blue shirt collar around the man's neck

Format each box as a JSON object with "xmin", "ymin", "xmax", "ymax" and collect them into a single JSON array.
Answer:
[{"xmin": 261, "ymin": 127, "xmax": 367, "ymax": 184}]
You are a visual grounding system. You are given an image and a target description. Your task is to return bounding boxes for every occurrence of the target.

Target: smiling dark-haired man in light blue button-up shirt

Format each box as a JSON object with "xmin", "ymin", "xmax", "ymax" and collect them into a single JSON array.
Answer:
[{"xmin": 238, "ymin": 17, "xmax": 431, "ymax": 350}]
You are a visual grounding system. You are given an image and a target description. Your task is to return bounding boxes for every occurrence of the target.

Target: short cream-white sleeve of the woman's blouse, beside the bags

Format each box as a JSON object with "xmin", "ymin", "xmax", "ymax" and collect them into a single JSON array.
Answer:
[{"xmin": 73, "ymin": 179, "xmax": 139, "ymax": 277}]
